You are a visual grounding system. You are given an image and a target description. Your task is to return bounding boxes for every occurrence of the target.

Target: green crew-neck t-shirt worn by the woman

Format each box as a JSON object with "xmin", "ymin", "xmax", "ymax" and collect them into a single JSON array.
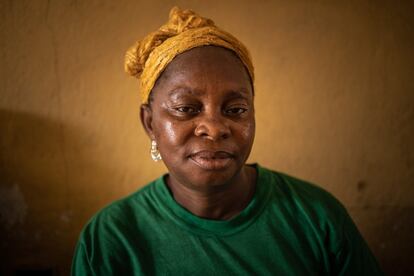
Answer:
[{"xmin": 72, "ymin": 165, "xmax": 382, "ymax": 275}]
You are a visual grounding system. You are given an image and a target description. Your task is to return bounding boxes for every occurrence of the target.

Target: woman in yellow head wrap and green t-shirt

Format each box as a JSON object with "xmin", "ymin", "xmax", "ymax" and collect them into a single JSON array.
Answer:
[{"xmin": 72, "ymin": 8, "xmax": 381, "ymax": 275}]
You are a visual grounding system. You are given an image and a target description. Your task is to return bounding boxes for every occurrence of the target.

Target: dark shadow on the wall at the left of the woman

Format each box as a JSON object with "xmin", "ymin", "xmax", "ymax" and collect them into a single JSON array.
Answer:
[{"xmin": 0, "ymin": 110, "xmax": 121, "ymax": 275}]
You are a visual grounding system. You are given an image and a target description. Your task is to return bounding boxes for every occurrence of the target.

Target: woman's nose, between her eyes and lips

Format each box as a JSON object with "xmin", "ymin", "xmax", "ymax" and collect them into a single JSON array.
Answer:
[{"xmin": 194, "ymin": 115, "xmax": 231, "ymax": 141}]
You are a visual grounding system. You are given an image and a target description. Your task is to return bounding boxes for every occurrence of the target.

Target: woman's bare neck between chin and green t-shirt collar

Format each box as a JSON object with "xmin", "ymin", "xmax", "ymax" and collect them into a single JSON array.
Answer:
[{"xmin": 167, "ymin": 166, "xmax": 256, "ymax": 220}]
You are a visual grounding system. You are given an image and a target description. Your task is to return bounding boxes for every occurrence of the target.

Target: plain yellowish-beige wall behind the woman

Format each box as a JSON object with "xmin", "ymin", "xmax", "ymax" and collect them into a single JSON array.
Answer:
[{"xmin": 0, "ymin": 0, "xmax": 414, "ymax": 275}]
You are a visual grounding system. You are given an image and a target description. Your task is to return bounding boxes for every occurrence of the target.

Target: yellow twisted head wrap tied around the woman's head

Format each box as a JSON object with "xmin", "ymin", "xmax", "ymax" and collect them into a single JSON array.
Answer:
[{"xmin": 125, "ymin": 7, "xmax": 254, "ymax": 103}]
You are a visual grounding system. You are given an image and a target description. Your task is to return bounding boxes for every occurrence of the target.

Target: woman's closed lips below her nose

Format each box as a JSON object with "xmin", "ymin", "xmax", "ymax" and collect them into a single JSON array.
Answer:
[{"xmin": 190, "ymin": 150, "xmax": 234, "ymax": 170}]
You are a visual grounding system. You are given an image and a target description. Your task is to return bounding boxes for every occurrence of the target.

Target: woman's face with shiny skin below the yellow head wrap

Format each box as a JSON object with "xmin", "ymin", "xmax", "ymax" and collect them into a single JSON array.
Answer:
[{"xmin": 141, "ymin": 46, "xmax": 255, "ymax": 190}]
